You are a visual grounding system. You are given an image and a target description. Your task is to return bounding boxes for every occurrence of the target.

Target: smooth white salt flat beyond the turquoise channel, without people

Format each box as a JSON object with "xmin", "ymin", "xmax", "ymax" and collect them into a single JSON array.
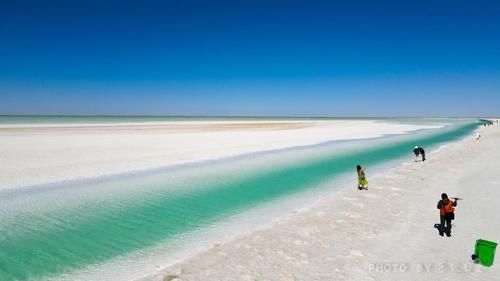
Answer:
[{"xmin": 0, "ymin": 120, "xmax": 440, "ymax": 189}]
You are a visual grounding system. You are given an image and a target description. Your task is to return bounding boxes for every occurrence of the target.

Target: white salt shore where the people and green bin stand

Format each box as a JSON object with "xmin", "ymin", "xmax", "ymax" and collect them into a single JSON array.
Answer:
[{"xmin": 150, "ymin": 126, "xmax": 500, "ymax": 281}]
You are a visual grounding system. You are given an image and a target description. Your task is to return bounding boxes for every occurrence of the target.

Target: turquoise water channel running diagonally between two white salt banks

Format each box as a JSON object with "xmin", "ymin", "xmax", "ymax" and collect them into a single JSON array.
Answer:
[{"xmin": 0, "ymin": 119, "xmax": 478, "ymax": 280}]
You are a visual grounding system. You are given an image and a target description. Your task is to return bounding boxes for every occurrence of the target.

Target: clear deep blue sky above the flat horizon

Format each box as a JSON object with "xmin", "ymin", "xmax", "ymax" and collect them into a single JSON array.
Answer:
[{"xmin": 0, "ymin": 0, "xmax": 500, "ymax": 116}]
